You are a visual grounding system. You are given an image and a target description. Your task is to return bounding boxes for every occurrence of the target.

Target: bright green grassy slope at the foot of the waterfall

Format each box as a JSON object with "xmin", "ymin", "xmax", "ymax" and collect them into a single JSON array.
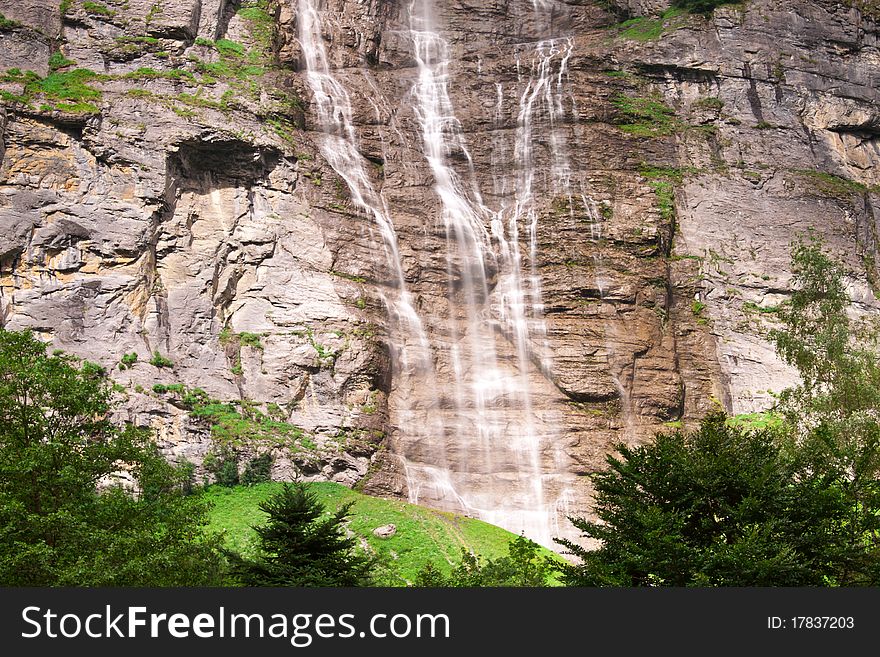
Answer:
[{"xmin": 205, "ymin": 482, "xmax": 553, "ymax": 586}]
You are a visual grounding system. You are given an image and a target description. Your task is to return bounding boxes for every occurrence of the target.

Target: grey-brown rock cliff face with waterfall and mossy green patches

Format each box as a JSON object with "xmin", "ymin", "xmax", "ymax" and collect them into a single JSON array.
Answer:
[{"xmin": 0, "ymin": 0, "xmax": 880, "ymax": 542}]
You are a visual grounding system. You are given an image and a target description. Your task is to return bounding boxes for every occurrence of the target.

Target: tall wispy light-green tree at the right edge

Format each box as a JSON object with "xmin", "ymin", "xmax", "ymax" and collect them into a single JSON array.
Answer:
[{"xmin": 770, "ymin": 238, "xmax": 880, "ymax": 584}]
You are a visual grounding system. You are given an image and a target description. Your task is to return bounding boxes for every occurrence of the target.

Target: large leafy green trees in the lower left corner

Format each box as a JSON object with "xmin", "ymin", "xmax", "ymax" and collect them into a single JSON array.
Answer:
[{"xmin": 0, "ymin": 329, "xmax": 221, "ymax": 586}]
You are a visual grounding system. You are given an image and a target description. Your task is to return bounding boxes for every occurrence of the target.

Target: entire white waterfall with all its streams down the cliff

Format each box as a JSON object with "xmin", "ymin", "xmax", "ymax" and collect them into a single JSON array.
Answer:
[{"xmin": 298, "ymin": 0, "xmax": 572, "ymax": 546}]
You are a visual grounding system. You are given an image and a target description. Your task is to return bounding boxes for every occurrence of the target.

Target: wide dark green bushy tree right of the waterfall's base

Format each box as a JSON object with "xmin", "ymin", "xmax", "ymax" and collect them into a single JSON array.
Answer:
[{"xmin": 559, "ymin": 413, "xmax": 860, "ymax": 586}]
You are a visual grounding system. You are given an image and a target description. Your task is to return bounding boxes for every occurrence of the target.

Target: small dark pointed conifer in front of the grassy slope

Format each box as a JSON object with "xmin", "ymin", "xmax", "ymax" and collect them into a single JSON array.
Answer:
[{"xmin": 229, "ymin": 482, "xmax": 375, "ymax": 587}]
